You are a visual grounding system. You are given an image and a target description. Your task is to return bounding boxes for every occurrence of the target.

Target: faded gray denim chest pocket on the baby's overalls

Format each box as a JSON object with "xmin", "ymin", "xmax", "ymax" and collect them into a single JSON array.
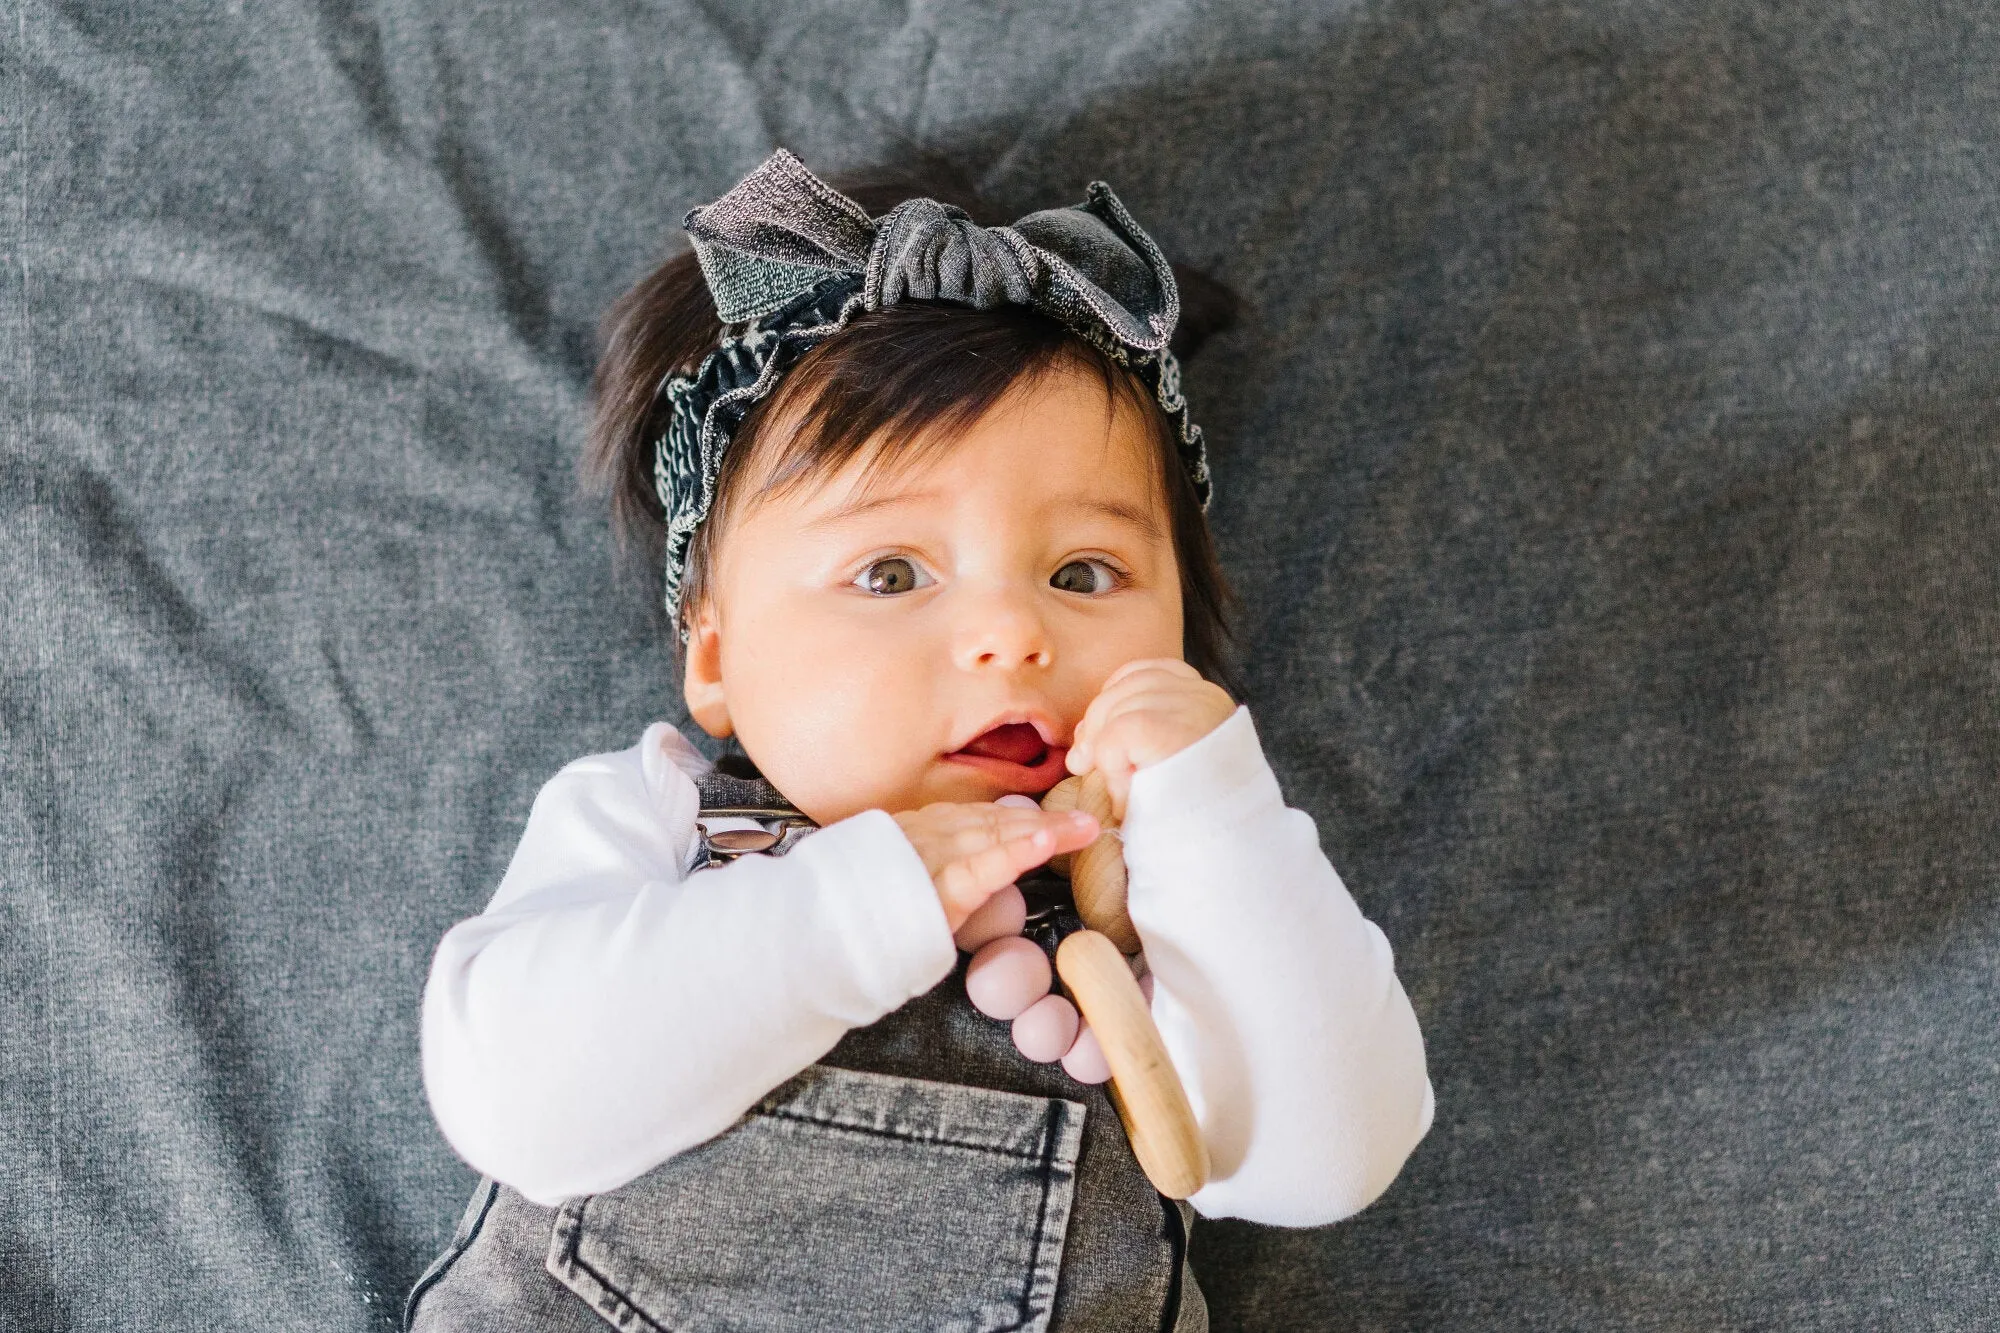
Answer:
[{"xmin": 548, "ymin": 1065, "xmax": 1084, "ymax": 1333}]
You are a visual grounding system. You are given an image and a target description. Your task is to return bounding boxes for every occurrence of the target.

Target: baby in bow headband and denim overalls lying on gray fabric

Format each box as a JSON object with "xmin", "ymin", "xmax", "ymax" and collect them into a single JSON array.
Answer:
[{"xmin": 408, "ymin": 152, "xmax": 1432, "ymax": 1333}]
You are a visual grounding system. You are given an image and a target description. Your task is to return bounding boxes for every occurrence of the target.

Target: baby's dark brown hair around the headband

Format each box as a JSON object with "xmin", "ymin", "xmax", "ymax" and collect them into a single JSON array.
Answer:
[{"xmin": 580, "ymin": 160, "xmax": 1242, "ymax": 699}]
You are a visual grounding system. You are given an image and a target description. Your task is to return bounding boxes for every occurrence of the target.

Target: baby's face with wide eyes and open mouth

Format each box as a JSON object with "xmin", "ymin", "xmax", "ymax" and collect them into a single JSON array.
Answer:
[{"xmin": 686, "ymin": 366, "xmax": 1182, "ymax": 825}]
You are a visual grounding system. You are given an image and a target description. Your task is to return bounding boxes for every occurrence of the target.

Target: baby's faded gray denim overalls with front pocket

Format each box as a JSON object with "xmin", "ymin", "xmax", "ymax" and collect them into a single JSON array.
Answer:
[{"xmin": 404, "ymin": 771, "xmax": 1208, "ymax": 1333}]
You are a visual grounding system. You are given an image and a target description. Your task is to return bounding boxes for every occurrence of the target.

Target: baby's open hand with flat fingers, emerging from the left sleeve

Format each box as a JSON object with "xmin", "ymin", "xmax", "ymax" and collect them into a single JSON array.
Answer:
[{"xmin": 894, "ymin": 801, "xmax": 1098, "ymax": 935}]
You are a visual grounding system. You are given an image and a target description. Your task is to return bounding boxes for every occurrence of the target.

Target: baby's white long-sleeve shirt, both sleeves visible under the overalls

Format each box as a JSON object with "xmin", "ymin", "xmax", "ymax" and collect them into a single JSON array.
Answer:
[{"xmin": 422, "ymin": 707, "xmax": 1432, "ymax": 1227}]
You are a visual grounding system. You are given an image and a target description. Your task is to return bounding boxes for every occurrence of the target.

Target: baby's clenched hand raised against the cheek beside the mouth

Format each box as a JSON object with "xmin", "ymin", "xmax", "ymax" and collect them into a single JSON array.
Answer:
[{"xmin": 1068, "ymin": 656, "xmax": 1236, "ymax": 817}]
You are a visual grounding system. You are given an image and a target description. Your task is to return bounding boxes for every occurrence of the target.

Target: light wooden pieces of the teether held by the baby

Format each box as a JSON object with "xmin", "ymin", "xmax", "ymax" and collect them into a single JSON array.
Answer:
[{"xmin": 1042, "ymin": 773, "xmax": 1208, "ymax": 1199}]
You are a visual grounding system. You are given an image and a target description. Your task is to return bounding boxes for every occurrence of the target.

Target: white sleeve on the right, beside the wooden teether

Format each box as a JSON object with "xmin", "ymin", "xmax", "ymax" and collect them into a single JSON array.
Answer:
[{"xmin": 1122, "ymin": 707, "xmax": 1432, "ymax": 1227}]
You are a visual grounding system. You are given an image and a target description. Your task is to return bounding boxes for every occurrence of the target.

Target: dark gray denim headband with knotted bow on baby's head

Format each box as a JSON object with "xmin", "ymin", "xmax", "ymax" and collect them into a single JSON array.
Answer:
[{"xmin": 654, "ymin": 148, "xmax": 1210, "ymax": 624}]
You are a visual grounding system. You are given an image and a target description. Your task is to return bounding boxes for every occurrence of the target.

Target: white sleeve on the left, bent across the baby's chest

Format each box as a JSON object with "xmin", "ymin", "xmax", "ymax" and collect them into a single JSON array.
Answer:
[{"xmin": 422, "ymin": 723, "xmax": 958, "ymax": 1205}]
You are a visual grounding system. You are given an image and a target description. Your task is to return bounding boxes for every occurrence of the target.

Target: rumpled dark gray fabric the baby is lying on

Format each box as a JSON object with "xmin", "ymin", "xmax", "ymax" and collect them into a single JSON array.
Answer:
[{"xmin": 0, "ymin": 0, "xmax": 2000, "ymax": 1333}]
